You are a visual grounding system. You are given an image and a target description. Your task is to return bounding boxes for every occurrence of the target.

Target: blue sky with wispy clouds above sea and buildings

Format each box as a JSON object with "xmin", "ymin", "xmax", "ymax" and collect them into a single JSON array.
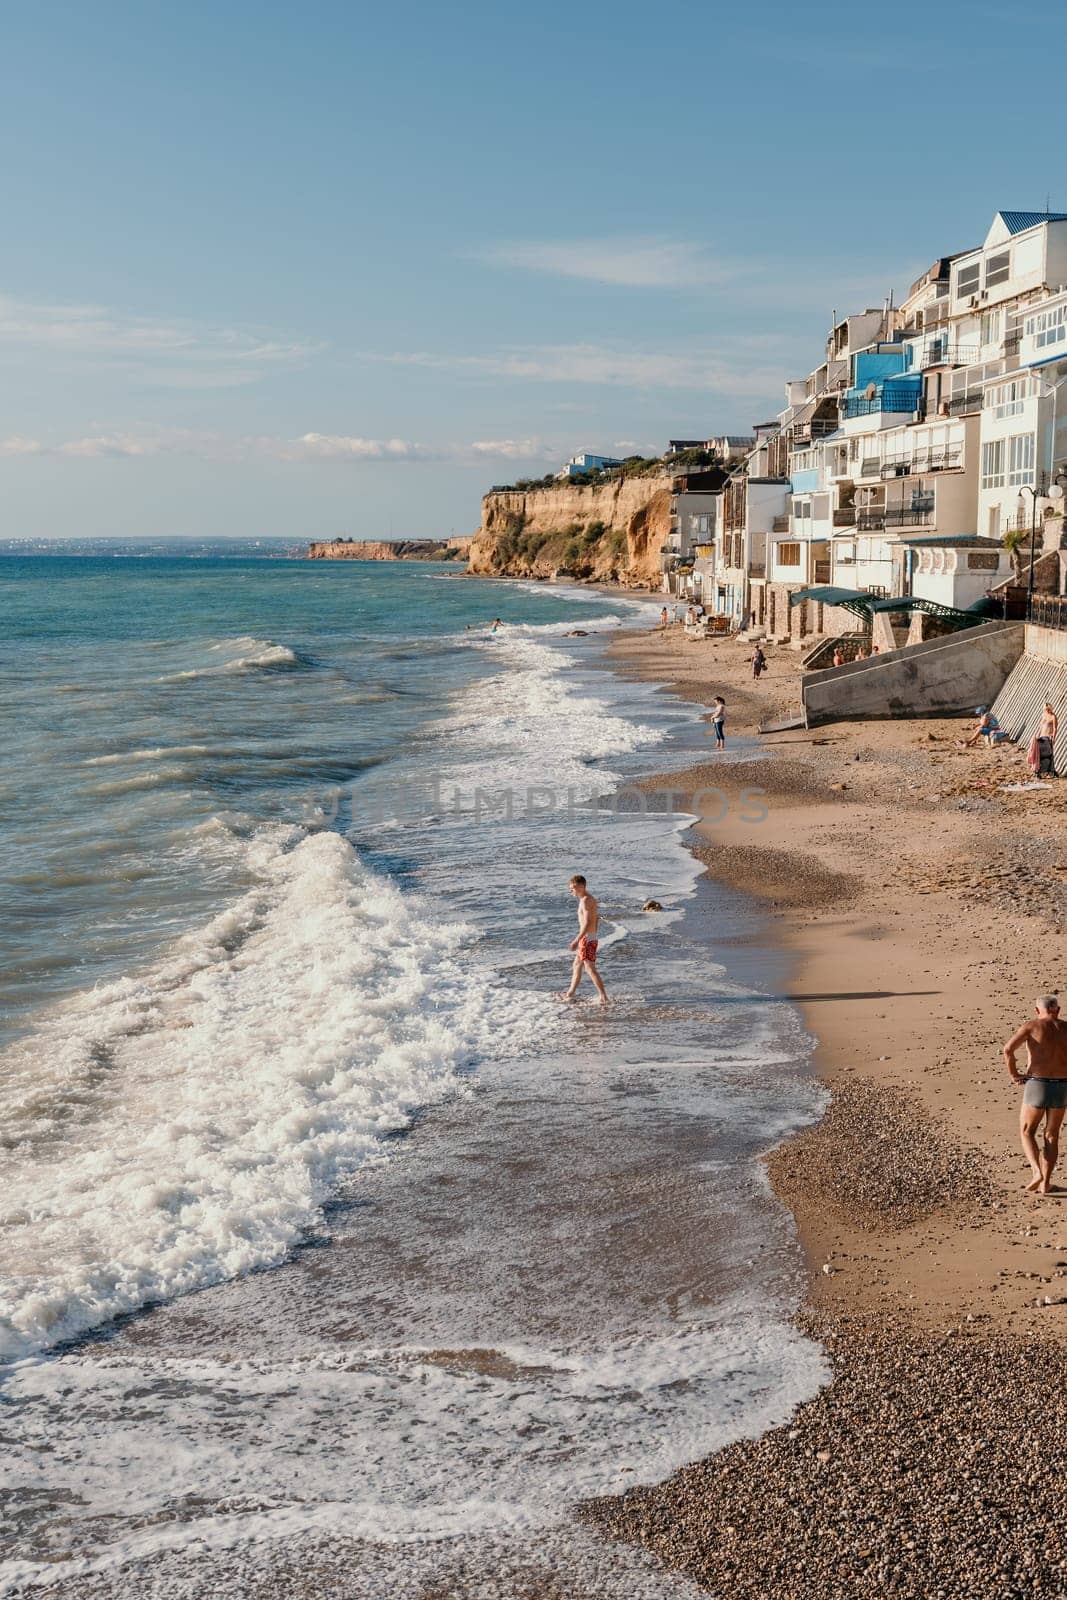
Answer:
[{"xmin": 0, "ymin": 0, "xmax": 1067, "ymax": 539}]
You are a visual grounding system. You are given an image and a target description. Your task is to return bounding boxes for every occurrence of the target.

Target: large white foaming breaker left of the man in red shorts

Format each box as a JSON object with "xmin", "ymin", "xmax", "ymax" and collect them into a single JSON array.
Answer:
[{"xmin": 0, "ymin": 827, "xmax": 553, "ymax": 1360}]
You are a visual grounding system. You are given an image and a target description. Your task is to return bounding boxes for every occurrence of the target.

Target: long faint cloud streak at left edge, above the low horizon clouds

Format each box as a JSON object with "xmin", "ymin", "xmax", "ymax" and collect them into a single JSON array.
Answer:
[{"xmin": 0, "ymin": 294, "xmax": 322, "ymax": 389}]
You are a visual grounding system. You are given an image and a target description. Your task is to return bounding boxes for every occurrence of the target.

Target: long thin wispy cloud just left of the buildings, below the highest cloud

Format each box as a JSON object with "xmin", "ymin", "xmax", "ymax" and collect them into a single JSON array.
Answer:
[{"xmin": 370, "ymin": 344, "xmax": 787, "ymax": 397}]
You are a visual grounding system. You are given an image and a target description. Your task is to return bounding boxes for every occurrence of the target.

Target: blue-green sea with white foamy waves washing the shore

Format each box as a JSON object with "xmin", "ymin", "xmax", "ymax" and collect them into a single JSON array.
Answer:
[{"xmin": 0, "ymin": 544, "xmax": 827, "ymax": 1600}]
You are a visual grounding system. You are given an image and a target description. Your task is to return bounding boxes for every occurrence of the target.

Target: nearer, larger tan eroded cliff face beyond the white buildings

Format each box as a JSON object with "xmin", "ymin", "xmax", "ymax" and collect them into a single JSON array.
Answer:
[{"xmin": 470, "ymin": 472, "xmax": 673, "ymax": 589}]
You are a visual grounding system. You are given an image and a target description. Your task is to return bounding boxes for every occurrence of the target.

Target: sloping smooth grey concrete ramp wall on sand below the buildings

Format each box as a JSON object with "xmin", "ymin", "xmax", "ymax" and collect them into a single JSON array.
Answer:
[{"xmin": 801, "ymin": 622, "xmax": 1023, "ymax": 728}]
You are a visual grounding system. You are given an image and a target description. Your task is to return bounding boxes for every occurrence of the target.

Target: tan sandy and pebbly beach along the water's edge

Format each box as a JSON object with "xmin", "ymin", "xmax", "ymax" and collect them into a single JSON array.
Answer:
[{"xmin": 584, "ymin": 629, "xmax": 1067, "ymax": 1600}]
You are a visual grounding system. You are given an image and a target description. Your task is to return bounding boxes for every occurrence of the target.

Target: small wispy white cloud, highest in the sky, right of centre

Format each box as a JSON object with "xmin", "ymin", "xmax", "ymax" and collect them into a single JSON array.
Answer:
[{"xmin": 478, "ymin": 237, "xmax": 737, "ymax": 290}]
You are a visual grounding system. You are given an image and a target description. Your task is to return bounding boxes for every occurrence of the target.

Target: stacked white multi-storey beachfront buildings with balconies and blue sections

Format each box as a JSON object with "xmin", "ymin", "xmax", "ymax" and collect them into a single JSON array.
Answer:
[{"xmin": 684, "ymin": 211, "xmax": 1067, "ymax": 640}]
